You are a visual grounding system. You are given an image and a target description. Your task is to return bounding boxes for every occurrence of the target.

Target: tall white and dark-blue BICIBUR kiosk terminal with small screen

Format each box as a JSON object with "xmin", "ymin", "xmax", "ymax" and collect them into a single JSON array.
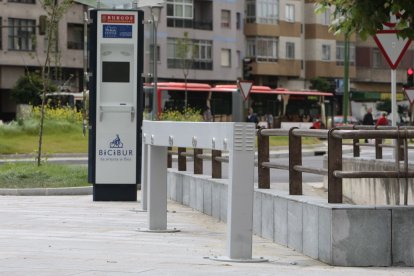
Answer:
[{"xmin": 89, "ymin": 10, "xmax": 143, "ymax": 201}]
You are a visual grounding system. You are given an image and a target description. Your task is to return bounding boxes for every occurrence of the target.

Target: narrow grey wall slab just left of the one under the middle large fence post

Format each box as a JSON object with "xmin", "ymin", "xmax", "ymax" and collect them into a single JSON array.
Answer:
[{"xmin": 273, "ymin": 197, "xmax": 288, "ymax": 246}]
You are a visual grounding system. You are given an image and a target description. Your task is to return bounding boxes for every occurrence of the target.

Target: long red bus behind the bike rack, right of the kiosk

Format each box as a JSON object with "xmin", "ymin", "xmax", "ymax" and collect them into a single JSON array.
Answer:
[{"xmin": 144, "ymin": 82, "xmax": 333, "ymax": 125}]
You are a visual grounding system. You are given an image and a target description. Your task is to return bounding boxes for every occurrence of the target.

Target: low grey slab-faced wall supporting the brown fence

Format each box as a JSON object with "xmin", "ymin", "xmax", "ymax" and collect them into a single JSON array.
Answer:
[{"xmin": 168, "ymin": 169, "xmax": 414, "ymax": 266}]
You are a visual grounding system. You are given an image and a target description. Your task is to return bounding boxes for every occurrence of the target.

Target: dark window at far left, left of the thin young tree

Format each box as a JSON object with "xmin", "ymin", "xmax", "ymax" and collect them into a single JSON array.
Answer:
[{"xmin": 8, "ymin": 18, "xmax": 36, "ymax": 51}]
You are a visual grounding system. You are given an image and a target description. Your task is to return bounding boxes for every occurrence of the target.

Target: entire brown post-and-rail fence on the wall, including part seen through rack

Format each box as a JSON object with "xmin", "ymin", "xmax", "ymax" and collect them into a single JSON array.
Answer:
[{"xmin": 167, "ymin": 126, "xmax": 414, "ymax": 205}]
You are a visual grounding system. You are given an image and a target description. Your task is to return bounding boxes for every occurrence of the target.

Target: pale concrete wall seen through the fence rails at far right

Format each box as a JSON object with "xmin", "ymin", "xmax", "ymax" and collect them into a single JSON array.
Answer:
[{"xmin": 324, "ymin": 157, "xmax": 414, "ymax": 205}]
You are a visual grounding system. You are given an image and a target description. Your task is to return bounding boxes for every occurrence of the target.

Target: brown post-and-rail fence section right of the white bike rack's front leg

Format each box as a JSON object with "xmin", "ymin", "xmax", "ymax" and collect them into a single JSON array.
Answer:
[{"xmin": 258, "ymin": 126, "xmax": 414, "ymax": 205}]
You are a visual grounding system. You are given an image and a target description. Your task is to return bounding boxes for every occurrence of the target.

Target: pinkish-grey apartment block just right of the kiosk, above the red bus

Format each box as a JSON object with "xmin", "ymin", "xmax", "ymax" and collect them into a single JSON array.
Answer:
[{"xmin": 144, "ymin": 0, "xmax": 246, "ymax": 83}]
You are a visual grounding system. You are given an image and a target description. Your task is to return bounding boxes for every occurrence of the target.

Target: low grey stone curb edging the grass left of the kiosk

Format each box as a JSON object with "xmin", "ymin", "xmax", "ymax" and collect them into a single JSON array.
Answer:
[{"xmin": 0, "ymin": 186, "xmax": 93, "ymax": 196}]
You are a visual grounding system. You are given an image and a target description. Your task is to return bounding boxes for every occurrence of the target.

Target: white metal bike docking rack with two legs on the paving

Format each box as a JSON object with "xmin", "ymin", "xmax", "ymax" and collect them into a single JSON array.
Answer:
[{"xmin": 140, "ymin": 121, "xmax": 267, "ymax": 262}]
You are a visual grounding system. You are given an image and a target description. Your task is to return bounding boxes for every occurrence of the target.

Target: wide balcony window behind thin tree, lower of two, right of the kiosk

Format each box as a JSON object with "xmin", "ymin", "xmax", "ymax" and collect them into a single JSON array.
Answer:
[{"xmin": 167, "ymin": 38, "xmax": 213, "ymax": 70}]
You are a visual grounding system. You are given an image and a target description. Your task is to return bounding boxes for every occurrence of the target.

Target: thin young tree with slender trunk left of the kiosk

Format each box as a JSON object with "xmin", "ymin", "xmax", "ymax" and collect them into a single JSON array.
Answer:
[{"xmin": 37, "ymin": 0, "xmax": 72, "ymax": 166}]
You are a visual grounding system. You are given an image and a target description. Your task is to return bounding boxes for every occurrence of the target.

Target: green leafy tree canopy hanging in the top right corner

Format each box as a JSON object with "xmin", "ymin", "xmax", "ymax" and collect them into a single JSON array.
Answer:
[{"xmin": 315, "ymin": 0, "xmax": 414, "ymax": 39}]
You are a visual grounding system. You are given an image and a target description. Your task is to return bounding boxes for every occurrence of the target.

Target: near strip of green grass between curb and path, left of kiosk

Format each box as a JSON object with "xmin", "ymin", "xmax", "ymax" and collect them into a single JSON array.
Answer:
[{"xmin": 0, "ymin": 162, "xmax": 90, "ymax": 189}]
